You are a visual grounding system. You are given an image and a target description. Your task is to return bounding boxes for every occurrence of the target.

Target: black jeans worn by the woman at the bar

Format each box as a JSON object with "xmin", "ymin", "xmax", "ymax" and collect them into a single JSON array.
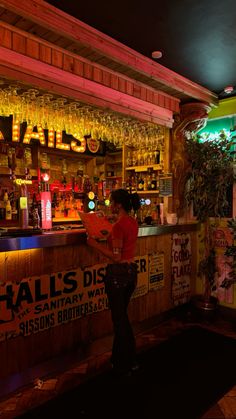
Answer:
[{"xmin": 104, "ymin": 263, "xmax": 137, "ymax": 371}]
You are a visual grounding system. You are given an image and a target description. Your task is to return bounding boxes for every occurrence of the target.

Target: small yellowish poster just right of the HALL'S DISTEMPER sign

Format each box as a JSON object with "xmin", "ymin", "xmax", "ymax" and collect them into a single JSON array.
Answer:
[{"xmin": 148, "ymin": 252, "xmax": 164, "ymax": 291}]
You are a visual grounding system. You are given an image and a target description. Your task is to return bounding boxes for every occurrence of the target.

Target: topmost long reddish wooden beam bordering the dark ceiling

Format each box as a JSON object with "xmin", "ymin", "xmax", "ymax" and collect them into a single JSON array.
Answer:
[{"xmin": 0, "ymin": 0, "xmax": 218, "ymax": 105}]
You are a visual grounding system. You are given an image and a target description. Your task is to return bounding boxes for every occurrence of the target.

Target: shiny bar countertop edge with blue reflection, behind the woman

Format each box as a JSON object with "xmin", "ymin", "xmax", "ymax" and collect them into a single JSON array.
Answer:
[{"xmin": 0, "ymin": 223, "xmax": 198, "ymax": 252}]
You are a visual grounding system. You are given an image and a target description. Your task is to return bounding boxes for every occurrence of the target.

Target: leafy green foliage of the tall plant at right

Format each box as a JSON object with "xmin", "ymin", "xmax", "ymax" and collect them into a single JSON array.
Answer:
[{"xmin": 185, "ymin": 131, "xmax": 236, "ymax": 221}]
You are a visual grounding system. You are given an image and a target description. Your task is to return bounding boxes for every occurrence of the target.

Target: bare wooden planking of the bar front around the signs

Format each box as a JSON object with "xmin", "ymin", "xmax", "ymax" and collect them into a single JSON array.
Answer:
[{"xmin": 0, "ymin": 224, "xmax": 197, "ymax": 379}]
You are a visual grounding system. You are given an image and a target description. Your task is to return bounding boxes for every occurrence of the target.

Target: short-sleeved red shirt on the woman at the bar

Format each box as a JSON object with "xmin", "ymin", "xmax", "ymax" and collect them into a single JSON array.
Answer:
[{"xmin": 108, "ymin": 215, "xmax": 138, "ymax": 261}]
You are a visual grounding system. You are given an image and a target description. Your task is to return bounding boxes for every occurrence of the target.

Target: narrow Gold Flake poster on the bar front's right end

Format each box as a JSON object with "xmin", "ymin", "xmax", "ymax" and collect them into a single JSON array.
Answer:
[{"xmin": 172, "ymin": 233, "xmax": 192, "ymax": 305}]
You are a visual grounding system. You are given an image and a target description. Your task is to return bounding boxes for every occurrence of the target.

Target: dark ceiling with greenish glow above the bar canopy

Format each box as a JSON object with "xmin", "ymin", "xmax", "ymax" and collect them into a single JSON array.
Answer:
[{"xmin": 47, "ymin": 0, "xmax": 236, "ymax": 99}]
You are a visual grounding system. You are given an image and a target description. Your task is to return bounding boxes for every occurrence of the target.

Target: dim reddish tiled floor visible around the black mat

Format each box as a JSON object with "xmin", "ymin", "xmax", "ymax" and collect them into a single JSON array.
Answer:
[{"xmin": 0, "ymin": 311, "xmax": 236, "ymax": 419}]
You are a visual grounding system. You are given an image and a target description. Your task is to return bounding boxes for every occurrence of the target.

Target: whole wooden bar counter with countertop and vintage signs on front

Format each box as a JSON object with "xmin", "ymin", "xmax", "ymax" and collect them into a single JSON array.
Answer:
[{"xmin": 0, "ymin": 223, "xmax": 198, "ymax": 379}]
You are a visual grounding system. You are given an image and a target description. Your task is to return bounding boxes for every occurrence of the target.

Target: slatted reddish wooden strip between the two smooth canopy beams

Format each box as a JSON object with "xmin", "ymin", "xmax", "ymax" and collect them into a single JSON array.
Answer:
[{"xmin": 0, "ymin": 22, "xmax": 180, "ymax": 112}]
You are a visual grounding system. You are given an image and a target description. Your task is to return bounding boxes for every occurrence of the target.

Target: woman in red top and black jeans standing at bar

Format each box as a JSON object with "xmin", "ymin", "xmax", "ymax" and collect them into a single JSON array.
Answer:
[{"xmin": 87, "ymin": 189, "xmax": 140, "ymax": 375}]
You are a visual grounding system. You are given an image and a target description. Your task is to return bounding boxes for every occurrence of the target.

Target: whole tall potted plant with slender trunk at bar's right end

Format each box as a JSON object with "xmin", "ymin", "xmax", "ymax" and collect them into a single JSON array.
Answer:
[{"xmin": 185, "ymin": 131, "xmax": 235, "ymax": 310}]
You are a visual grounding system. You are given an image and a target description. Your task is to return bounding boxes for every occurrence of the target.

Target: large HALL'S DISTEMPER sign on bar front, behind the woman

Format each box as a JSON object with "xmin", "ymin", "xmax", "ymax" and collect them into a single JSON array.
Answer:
[{"xmin": 0, "ymin": 255, "xmax": 148, "ymax": 341}]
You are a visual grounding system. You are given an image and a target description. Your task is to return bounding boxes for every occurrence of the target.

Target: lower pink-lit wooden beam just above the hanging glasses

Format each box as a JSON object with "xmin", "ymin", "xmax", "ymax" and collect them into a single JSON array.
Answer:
[{"xmin": 0, "ymin": 47, "xmax": 173, "ymax": 127}]
